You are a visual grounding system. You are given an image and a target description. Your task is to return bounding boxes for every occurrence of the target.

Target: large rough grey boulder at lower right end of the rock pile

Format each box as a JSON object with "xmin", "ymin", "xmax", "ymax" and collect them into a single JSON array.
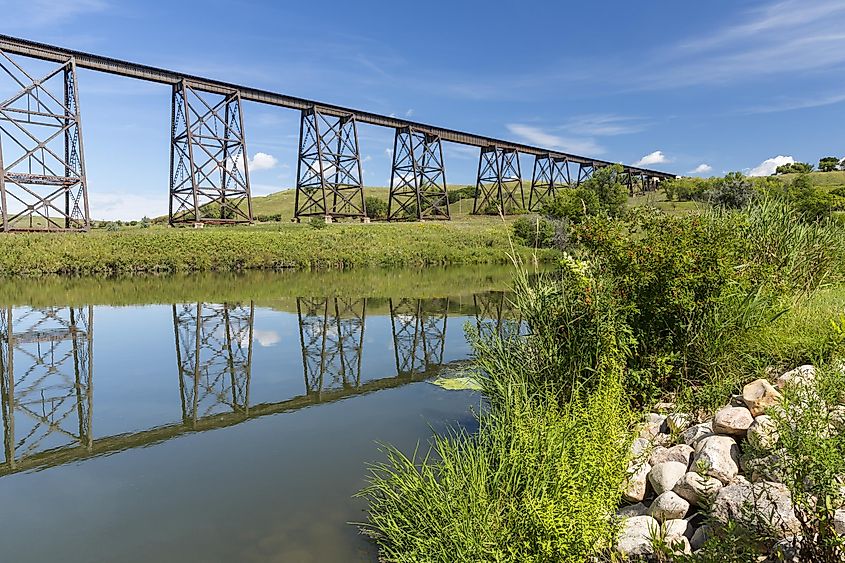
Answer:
[{"xmin": 710, "ymin": 481, "xmax": 801, "ymax": 538}]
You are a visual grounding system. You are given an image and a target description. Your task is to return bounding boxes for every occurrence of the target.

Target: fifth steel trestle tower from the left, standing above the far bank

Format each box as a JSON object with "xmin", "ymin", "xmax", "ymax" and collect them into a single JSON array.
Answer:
[{"xmin": 472, "ymin": 146, "xmax": 525, "ymax": 215}]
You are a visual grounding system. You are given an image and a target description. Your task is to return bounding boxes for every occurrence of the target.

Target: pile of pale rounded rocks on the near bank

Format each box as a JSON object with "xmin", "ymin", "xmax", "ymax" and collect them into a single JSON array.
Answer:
[{"xmin": 616, "ymin": 366, "xmax": 845, "ymax": 557}]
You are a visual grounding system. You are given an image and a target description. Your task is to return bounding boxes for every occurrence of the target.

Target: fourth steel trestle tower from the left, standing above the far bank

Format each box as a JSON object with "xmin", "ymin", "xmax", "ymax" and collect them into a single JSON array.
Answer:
[{"xmin": 387, "ymin": 127, "xmax": 451, "ymax": 221}]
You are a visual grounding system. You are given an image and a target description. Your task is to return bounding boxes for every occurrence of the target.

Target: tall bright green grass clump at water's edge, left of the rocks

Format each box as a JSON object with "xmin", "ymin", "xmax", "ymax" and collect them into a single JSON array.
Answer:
[{"xmin": 361, "ymin": 262, "xmax": 630, "ymax": 562}]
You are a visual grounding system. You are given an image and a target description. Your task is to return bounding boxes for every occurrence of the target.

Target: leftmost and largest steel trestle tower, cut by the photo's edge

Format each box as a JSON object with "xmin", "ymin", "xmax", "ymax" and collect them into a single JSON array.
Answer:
[{"xmin": 0, "ymin": 51, "xmax": 91, "ymax": 231}]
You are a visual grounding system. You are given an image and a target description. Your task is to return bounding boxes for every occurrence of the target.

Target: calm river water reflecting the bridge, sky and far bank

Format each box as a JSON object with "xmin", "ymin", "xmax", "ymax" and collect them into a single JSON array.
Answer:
[{"xmin": 0, "ymin": 269, "xmax": 513, "ymax": 562}]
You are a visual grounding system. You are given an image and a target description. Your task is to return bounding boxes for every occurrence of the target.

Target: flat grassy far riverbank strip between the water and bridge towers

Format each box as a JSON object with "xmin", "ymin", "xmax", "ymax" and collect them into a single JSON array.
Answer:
[{"xmin": 0, "ymin": 218, "xmax": 557, "ymax": 276}]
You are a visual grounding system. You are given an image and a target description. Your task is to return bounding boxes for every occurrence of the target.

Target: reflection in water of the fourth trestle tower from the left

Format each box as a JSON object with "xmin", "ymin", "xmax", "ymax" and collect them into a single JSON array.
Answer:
[{"xmin": 390, "ymin": 299, "xmax": 449, "ymax": 377}]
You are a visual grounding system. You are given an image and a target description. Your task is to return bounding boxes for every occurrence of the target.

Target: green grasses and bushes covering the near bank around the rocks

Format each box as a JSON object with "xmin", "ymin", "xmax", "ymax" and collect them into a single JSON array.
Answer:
[{"xmin": 361, "ymin": 170, "xmax": 845, "ymax": 563}]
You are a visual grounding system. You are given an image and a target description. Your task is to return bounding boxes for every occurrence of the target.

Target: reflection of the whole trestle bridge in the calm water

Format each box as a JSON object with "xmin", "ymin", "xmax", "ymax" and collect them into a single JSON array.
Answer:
[{"xmin": 0, "ymin": 293, "xmax": 512, "ymax": 476}]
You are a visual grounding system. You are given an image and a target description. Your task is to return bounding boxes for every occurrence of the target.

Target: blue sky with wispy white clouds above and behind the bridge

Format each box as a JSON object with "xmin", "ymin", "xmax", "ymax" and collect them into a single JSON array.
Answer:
[{"xmin": 0, "ymin": 0, "xmax": 845, "ymax": 218}]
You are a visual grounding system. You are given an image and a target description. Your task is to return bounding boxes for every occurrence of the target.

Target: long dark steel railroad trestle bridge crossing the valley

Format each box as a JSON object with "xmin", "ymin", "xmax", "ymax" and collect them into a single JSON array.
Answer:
[{"xmin": 0, "ymin": 35, "xmax": 673, "ymax": 232}]
